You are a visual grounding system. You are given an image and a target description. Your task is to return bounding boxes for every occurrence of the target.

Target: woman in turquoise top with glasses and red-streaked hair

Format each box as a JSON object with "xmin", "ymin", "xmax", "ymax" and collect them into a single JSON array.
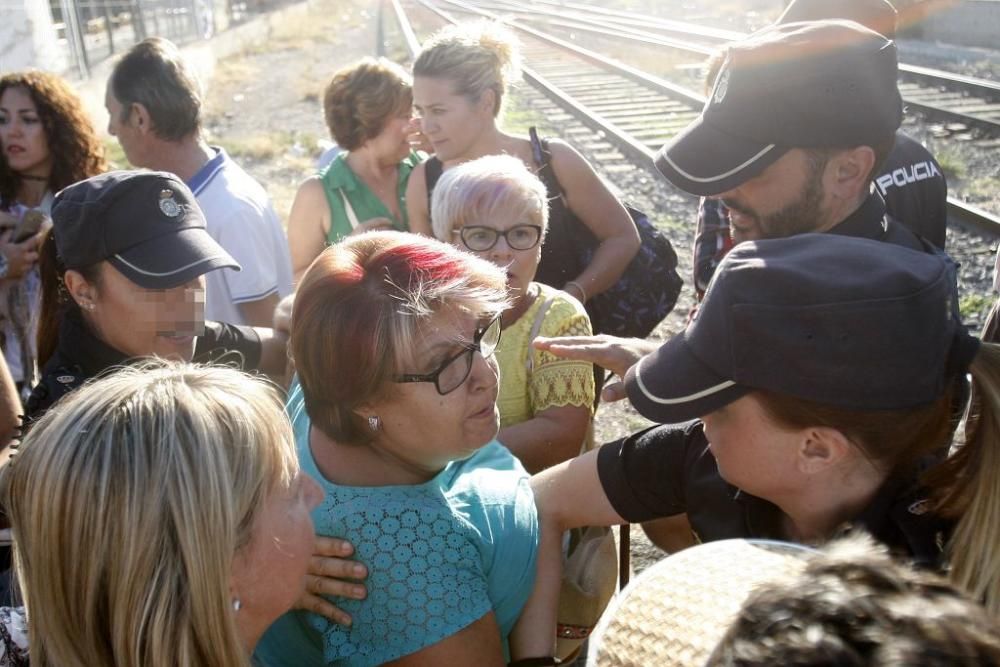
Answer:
[{"xmin": 258, "ymin": 232, "xmax": 538, "ymax": 666}]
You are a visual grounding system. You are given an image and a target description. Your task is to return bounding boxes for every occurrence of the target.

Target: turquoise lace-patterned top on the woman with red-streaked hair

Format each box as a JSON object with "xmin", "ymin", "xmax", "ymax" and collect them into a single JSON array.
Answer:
[{"xmin": 256, "ymin": 386, "xmax": 538, "ymax": 667}]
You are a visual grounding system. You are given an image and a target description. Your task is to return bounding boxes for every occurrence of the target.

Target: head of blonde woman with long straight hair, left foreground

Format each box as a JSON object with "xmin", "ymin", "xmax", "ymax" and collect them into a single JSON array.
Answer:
[{"xmin": 0, "ymin": 362, "xmax": 321, "ymax": 667}]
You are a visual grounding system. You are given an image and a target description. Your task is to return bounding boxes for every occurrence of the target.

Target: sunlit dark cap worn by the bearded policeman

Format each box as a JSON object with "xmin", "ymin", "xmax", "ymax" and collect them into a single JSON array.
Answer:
[{"xmin": 655, "ymin": 21, "xmax": 903, "ymax": 196}]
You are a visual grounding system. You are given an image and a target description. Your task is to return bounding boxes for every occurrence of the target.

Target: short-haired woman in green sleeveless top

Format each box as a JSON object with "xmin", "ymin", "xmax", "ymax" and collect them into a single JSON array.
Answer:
[{"xmin": 288, "ymin": 58, "xmax": 421, "ymax": 280}]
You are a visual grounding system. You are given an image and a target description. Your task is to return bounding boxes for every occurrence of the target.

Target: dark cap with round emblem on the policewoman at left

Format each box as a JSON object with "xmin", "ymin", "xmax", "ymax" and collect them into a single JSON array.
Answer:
[{"xmin": 52, "ymin": 171, "xmax": 240, "ymax": 289}]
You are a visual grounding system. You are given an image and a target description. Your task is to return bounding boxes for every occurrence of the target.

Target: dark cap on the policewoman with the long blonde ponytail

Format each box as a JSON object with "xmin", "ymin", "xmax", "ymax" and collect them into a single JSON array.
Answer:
[{"xmin": 625, "ymin": 234, "xmax": 976, "ymax": 423}]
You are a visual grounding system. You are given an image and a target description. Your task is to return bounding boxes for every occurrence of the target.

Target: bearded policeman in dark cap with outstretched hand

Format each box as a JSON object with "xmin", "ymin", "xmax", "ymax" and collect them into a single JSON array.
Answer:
[{"xmin": 535, "ymin": 21, "xmax": 956, "ymax": 544}]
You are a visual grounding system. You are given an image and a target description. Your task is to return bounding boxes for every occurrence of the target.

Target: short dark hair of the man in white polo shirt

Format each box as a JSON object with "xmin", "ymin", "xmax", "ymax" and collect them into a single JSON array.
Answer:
[{"xmin": 108, "ymin": 37, "xmax": 202, "ymax": 141}]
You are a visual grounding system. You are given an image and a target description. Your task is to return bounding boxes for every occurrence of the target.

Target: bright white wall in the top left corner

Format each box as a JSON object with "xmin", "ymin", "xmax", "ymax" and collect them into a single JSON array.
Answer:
[{"xmin": 0, "ymin": 0, "xmax": 69, "ymax": 72}]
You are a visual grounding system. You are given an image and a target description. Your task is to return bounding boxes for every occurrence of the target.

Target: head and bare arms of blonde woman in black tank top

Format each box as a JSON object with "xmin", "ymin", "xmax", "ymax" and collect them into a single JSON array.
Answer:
[{"xmin": 406, "ymin": 22, "xmax": 639, "ymax": 320}]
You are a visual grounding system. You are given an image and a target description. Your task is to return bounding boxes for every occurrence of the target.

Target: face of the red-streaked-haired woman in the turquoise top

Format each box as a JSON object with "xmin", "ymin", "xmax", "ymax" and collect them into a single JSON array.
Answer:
[{"xmin": 365, "ymin": 311, "xmax": 500, "ymax": 474}]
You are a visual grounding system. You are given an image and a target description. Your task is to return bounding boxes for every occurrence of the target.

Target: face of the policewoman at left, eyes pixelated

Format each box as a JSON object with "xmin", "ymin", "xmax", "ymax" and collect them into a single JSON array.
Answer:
[{"xmin": 75, "ymin": 262, "xmax": 205, "ymax": 361}]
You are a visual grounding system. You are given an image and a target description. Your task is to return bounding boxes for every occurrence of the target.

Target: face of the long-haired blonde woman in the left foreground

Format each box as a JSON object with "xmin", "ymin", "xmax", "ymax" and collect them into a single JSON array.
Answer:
[{"xmin": 232, "ymin": 472, "xmax": 323, "ymax": 649}]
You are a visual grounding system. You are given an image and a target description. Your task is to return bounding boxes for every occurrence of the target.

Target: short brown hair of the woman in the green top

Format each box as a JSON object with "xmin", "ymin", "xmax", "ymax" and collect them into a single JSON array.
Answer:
[{"xmin": 323, "ymin": 58, "xmax": 413, "ymax": 151}]
